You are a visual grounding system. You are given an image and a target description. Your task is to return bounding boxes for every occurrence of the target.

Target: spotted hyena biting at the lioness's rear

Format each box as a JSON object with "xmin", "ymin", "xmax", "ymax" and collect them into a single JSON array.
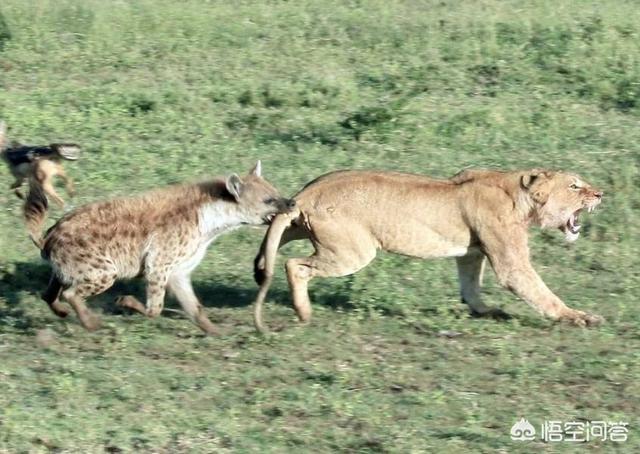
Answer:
[{"xmin": 30, "ymin": 162, "xmax": 295, "ymax": 334}]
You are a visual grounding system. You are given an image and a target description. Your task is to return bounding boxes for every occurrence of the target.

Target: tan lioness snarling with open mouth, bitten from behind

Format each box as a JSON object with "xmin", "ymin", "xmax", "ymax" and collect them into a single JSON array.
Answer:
[{"xmin": 254, "ymin": 169, "xmax": 603, "ymax": 331}]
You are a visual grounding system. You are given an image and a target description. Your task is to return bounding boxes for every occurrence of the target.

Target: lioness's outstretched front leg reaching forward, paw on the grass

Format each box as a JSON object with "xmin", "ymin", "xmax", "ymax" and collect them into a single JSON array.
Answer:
[{"xmin": 490, "ymin": 254, "xmax": 604, "ymax": 326}]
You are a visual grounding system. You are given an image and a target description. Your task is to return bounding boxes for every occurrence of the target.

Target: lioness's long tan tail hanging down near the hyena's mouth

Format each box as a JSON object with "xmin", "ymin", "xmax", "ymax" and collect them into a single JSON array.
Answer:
[{"xmin": 253, "ymin": 209, "xmax": 300, "ymax": 334}]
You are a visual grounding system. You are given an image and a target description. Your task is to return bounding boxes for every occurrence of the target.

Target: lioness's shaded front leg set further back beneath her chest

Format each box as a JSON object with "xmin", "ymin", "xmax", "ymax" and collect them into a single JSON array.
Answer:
[{"xmin": 456, "ymin": 252, "xmax": 510, "ymax": 319}]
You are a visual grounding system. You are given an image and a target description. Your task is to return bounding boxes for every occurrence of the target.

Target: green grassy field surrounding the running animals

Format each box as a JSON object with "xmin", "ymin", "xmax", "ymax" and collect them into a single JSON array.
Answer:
[{"xmin": 0, "ymin": 0, "xmax": 640, "ymax": 453}]
